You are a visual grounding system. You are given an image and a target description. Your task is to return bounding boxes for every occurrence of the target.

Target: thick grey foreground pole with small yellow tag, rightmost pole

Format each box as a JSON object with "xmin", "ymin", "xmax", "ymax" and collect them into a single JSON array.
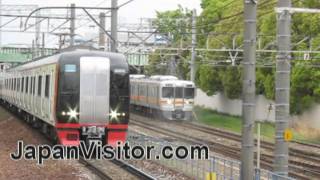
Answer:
[{"xmin": 274, "ymin": 0, "xmax": 291, "ymax": 176}]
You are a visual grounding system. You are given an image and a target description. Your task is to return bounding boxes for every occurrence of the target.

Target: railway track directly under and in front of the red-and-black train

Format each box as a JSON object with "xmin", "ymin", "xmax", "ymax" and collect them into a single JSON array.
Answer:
[{"xmin": 79, "ymin": 157, "xmax": 155, "ymax": 180}]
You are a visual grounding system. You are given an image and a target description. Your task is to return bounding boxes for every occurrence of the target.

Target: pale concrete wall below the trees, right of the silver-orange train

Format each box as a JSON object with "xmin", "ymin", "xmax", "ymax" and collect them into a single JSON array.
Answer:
[{"xmin": 195, "ymin": 89, "xmax": 275, "ymax": 122}]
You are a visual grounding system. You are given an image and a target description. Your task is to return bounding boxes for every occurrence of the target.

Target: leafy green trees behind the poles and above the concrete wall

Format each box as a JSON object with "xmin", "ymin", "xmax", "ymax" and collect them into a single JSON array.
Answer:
[{"xmin": 146, "ymin": 0, "xmax": 320, "ymax": 114}]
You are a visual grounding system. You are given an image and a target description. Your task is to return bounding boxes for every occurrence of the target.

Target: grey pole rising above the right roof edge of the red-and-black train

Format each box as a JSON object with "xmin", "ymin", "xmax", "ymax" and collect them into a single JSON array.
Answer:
[{"xmin": 111, "ymin": 0, "xmax": 118, "ymax": 52}]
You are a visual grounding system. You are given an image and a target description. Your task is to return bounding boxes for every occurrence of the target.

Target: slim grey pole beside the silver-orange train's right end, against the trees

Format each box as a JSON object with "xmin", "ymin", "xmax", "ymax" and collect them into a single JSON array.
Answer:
[{"xmin": 190, "ymin": 9, "xmax": 197, "ymax": 82}]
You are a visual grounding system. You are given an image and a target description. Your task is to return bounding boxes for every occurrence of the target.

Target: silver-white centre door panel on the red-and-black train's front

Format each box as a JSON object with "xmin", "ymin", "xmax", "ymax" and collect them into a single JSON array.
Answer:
[{"xmin": 79, "ymin": 57, "xmax": 110, "ymax": 124}]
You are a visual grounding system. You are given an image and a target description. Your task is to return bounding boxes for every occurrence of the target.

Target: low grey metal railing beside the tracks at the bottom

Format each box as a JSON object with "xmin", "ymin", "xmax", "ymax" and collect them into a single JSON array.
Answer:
[{"xmin": 128, "ymin": 131, "xmax": 294, "ymax": 180}]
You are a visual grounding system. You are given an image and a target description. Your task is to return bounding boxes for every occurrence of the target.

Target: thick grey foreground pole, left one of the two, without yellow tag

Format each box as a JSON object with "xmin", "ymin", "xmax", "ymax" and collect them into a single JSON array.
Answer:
[{"xmin": 241, "ymin": 0, "xmax": 257, "ymax": 180}]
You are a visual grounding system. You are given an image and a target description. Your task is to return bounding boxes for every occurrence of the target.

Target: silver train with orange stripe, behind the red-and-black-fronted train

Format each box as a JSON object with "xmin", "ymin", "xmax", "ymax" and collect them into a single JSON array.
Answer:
[{"xmin": 130, "ymin": 75, "xmax": 195, "ymax": 120}]
